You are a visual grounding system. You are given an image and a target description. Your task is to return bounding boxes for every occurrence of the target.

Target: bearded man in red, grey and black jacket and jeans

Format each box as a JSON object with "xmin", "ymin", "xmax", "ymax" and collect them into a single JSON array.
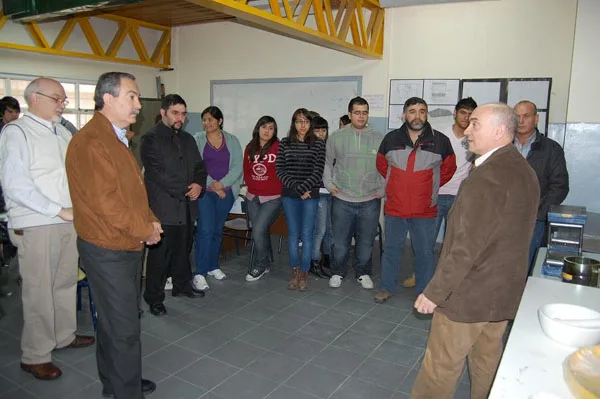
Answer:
[{"xmin": 375, "ymin": 97, "xmax": 456, "ymax": 303}]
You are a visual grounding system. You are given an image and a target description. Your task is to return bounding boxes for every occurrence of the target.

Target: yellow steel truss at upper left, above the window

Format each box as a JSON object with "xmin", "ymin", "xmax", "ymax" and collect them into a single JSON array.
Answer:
[{"xmin": 0, "ymin": 11, "xmax": 171, "ymax": 68}]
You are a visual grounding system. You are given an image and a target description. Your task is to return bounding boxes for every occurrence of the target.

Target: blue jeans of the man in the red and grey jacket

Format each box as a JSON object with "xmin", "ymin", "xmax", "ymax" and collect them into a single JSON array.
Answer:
[{"xmin": 381, "ymin": 215, "xmax": 436, "ymax": 295}]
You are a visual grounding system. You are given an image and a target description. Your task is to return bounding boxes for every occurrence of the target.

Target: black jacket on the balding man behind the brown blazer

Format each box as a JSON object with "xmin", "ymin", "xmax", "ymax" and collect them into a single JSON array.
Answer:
[{"xmin": 527, "ymin": 130, "xmax": 569, "ymax": 220}]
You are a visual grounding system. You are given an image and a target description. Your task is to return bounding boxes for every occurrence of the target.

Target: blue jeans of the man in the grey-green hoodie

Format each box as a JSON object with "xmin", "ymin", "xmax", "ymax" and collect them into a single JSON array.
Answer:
[{"xmin": 331, "ymin": 198, "xmax": 381, "ymax": 277}]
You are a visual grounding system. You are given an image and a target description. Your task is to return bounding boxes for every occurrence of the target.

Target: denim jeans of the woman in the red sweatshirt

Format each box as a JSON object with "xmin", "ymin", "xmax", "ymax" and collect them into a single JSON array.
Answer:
[{"xmin": 247, "ymin": 197, "xmax": 281, "ymax": 270}]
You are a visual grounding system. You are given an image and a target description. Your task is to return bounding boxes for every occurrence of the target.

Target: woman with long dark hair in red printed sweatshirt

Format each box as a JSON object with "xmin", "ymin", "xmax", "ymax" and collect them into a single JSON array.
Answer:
[{"xmin": 244, "ymin": 116, "xmax": 281, "ymax": 281}]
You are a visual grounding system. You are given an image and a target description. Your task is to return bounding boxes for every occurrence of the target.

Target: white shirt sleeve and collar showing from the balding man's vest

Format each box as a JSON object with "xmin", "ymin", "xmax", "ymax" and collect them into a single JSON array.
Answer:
[{"xmin": 0, "ymin": 112, "xmax": 62, "ymax": 217}]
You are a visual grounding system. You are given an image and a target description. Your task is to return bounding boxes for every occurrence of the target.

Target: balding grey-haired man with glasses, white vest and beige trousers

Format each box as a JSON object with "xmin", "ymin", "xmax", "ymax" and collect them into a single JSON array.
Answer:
[{"xmin": 0, "ymin": 78, "xmax": 94, "ymax": 380}]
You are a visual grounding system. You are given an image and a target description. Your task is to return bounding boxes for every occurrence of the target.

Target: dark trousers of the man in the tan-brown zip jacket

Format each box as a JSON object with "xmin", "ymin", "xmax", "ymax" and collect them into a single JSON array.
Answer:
[{"xmin": 77, "ymin": 238, "xmax": 144, "ymax": 399}]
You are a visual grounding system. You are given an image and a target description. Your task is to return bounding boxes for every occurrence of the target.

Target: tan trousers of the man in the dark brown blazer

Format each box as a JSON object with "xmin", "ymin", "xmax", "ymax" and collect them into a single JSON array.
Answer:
[{"xmin": 410, "ymin": 311, "xmax": 508, "ymax": 399}]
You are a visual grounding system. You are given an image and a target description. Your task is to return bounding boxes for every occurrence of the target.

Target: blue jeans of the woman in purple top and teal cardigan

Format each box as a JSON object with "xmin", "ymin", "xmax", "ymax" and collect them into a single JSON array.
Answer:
[{"xmin": 195, "ymin": 190, "xmax": 235, "ymax": 276}]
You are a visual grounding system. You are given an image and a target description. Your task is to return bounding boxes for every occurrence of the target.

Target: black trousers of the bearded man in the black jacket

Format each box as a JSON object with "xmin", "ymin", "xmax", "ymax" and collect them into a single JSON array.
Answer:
[{"xmin": 144, "ymin": 224, "xmax": 192, "ymax": 305}]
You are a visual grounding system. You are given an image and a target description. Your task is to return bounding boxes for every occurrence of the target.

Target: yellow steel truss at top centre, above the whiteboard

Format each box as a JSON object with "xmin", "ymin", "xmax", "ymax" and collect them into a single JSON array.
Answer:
[{"xmin": 187, "ymin": 0, "xmax": 385, "ymax": 59}]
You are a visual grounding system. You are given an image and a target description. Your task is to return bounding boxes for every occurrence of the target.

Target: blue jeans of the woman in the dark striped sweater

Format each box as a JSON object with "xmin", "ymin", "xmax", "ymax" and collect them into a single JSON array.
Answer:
[{"xmin": 281, "ymin": 197, "xmax": 319, "ymax": 272}]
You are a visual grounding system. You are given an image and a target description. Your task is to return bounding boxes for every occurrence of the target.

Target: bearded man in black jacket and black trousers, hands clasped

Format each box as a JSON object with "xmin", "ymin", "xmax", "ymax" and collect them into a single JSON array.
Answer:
[{"xmin": 141, "ymin": 94, "xmax": 206, "ymax": 316}]
